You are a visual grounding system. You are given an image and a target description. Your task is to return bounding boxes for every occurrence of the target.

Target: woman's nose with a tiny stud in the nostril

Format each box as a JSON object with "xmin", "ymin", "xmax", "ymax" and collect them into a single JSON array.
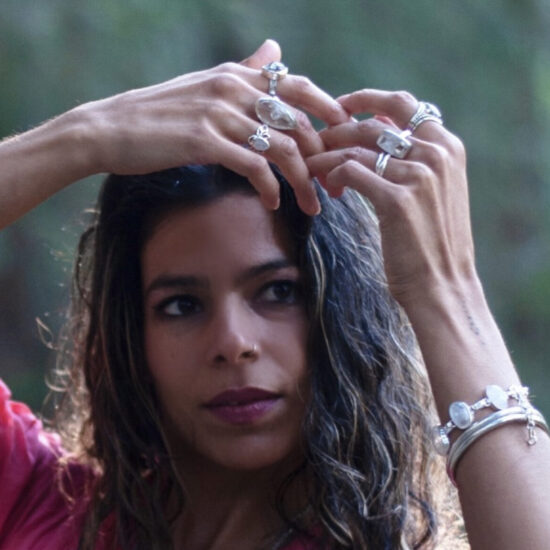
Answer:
[{"xmin": 207, "ymin": 301, "xmax": 260, "ymax": 366}]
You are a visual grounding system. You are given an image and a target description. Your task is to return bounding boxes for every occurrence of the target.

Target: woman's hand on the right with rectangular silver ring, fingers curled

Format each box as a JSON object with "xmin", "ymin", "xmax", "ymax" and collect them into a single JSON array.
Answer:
[{"xmin": 307, "ymin": 89, "xmax": 475, "ymax": 309}]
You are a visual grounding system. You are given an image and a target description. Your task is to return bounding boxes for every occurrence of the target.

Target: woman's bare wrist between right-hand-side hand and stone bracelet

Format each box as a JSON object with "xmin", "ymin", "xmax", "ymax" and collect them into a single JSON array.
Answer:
[{"xmin": 396, "ymin": 273, "xmax": 519, "ymax": 419}]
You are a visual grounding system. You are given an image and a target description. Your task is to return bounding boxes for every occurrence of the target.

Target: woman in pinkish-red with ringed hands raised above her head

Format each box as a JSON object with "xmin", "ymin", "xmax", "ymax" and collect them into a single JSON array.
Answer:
[{"xmin": 0, "ymin": 41, "xmax": 550, "ymax": 549}]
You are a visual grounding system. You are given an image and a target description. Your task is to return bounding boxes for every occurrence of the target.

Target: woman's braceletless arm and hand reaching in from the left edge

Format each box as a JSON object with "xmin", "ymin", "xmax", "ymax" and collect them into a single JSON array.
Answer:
[{"xmin": 0, "ymin": 40, "xmax": 349, "ymax": 227}]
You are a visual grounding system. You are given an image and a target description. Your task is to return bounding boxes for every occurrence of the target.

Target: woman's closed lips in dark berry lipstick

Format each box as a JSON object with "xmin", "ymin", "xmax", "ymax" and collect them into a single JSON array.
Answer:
[{"xmin": 205, "ymin": 388, "xmax": 281, "ymax": 424}]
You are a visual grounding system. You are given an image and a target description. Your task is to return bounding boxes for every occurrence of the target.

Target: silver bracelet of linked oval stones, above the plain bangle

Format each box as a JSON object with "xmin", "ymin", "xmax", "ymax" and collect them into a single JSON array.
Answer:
[{"xmin": 432, "ymin": 384, "xmax": 530, "ymax": 456}]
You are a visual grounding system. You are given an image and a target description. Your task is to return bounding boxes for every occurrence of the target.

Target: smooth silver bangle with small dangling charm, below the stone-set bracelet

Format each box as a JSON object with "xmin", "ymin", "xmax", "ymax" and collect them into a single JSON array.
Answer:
[{"xmin": 447, "ymin": 404, "xmax": 549, "ymax": 487}]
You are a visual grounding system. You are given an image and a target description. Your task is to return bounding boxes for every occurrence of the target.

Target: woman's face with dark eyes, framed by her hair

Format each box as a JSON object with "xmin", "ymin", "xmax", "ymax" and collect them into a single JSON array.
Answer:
[{"xmin": 141, "ymin": 194, "xmax": 308, "ymax": 470}]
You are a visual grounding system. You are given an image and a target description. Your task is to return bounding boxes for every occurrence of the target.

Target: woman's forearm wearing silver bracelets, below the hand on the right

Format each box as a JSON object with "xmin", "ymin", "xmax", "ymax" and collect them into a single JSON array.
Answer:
[{"xmin": 408, "ymin": 279, "xmax": 550, "ymax": 550}]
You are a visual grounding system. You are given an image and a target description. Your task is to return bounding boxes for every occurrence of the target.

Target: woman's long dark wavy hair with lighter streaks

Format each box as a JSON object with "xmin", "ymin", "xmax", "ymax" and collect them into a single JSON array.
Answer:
[{"xmin": 50, "ymin": 166, "xmax": 462, "ymax": 550}]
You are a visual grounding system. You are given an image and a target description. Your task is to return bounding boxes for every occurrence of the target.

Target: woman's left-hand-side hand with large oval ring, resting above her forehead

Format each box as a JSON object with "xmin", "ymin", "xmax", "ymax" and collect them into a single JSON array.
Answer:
[{"xmin": 74, "ymin": 40, "xmax": 349, "ymax": 214}]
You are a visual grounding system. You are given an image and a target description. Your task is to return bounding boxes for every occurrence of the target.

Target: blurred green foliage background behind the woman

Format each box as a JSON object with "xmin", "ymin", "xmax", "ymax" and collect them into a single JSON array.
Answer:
[{"xmin": 0, "ymin": 0, "xmax": 550, "ymax": 416}]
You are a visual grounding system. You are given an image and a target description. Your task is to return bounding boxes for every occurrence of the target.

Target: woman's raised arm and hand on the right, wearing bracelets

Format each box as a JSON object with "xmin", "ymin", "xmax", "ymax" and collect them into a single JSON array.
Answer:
[{"xmin": 308, "ymin": 90, "xmax": 550, "ymax": 550}]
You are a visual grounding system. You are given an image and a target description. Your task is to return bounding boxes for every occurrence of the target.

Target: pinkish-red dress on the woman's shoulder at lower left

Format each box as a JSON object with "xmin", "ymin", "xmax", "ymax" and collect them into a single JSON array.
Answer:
[{"xmin": 0, "ymin": 380, "xmax": 318, "ymax": 550}]
